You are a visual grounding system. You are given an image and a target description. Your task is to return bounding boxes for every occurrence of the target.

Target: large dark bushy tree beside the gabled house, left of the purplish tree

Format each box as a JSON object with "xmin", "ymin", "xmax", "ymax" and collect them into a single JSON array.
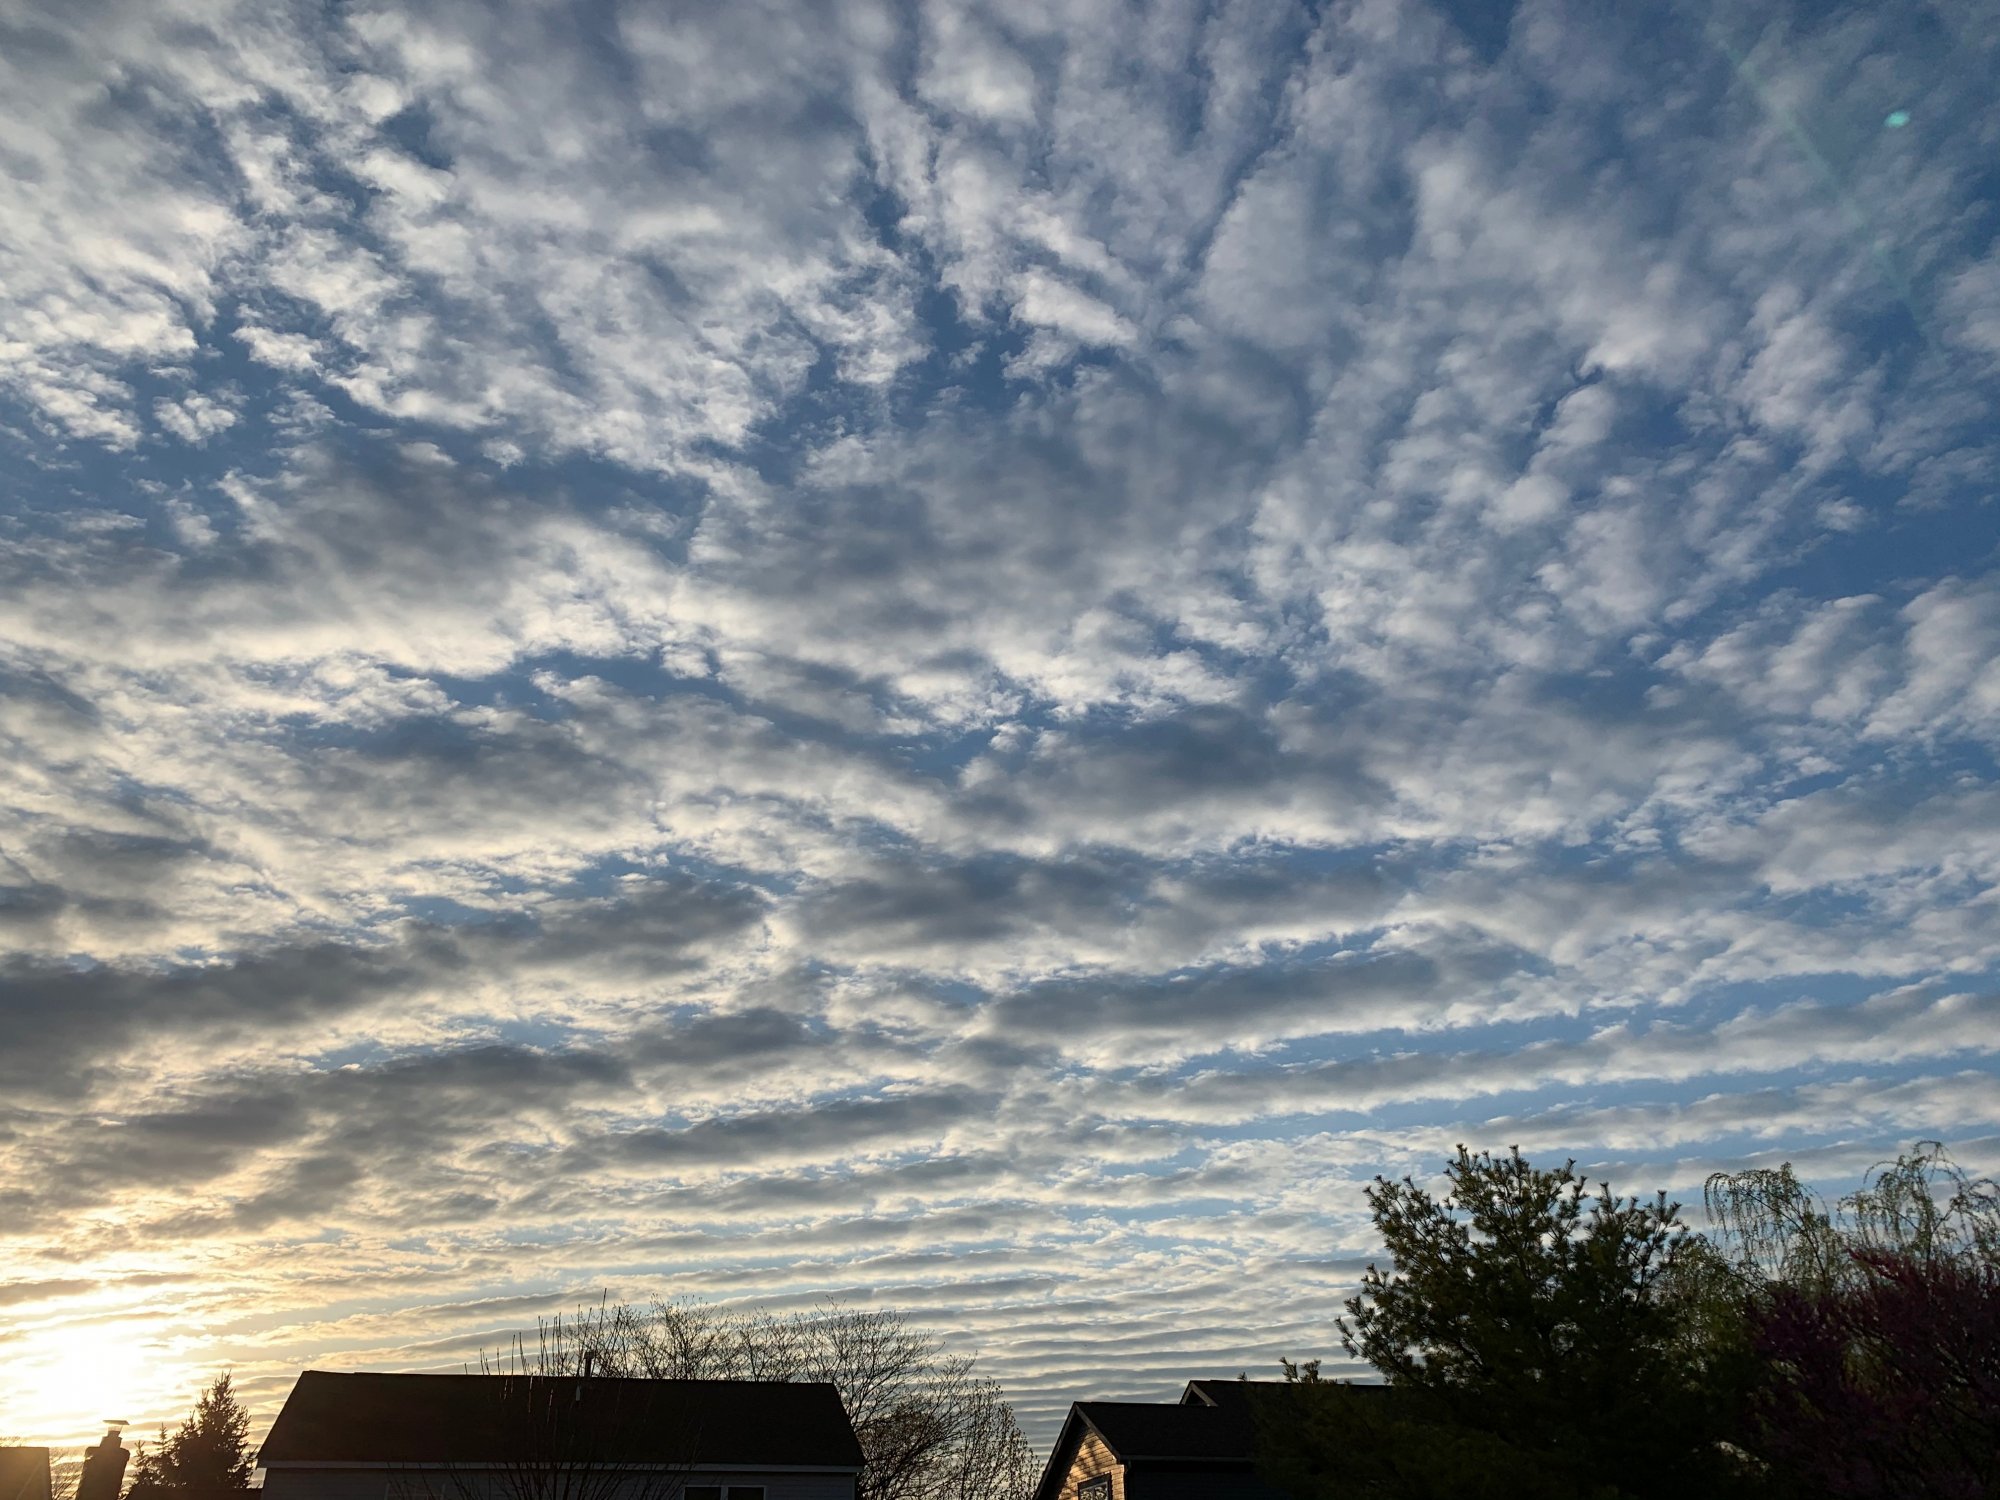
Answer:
[{"xmin": 1264, "ymin": 1146, "xmax": 1736, "ymax": 1500}]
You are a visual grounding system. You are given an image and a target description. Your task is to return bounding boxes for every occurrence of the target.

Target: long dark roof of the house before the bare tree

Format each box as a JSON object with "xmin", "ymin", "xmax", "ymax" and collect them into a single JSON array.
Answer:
[{"xmin": 258, "ymin": 1370, "xmax": 862, "ymax": 1470}]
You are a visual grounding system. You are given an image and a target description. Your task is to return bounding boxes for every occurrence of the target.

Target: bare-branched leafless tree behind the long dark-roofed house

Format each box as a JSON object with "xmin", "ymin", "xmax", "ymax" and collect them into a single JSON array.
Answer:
[{"xmin": 482, "ymin": 1300, "xmax": 1036, "ymax": 1500}]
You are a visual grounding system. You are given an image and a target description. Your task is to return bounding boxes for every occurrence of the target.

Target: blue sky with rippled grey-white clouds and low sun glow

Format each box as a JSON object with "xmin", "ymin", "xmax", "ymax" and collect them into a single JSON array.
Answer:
[{"xmin": 0, "ymin": 0, "xmax": 2000, "ymax": 1444}]
